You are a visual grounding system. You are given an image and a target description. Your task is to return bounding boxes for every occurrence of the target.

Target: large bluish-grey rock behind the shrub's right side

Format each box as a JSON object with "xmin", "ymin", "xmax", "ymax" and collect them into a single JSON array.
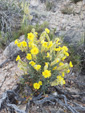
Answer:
[{"xmin": 56, "ymin": 28, "xmax": 84, "ymax": 53}]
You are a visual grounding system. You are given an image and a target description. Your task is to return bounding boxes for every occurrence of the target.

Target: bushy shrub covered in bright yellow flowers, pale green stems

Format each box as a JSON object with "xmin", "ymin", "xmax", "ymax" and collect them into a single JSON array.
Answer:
[{"xmin": 15, "ymin": 28, "xmax": 73, "ymax": 90}]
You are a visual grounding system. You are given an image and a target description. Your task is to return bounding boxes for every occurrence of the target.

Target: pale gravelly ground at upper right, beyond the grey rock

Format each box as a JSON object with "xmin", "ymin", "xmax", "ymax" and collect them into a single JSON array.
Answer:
[{"xmin": 30, "ymin": 0, "xmax": 85, "ymax": 31}]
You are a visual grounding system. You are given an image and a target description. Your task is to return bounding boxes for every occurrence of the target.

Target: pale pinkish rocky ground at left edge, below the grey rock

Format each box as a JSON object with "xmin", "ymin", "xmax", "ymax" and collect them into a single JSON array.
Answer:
[{"xmin": 0, "ymin": 50, "xmax": 23, "ymax": 95}]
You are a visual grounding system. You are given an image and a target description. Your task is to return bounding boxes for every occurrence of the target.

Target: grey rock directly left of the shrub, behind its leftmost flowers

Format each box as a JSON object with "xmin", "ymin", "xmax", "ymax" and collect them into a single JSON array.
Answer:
[{"xmin": 3, "ymin": 35, "xmax": 25, "ymax": 58}]
